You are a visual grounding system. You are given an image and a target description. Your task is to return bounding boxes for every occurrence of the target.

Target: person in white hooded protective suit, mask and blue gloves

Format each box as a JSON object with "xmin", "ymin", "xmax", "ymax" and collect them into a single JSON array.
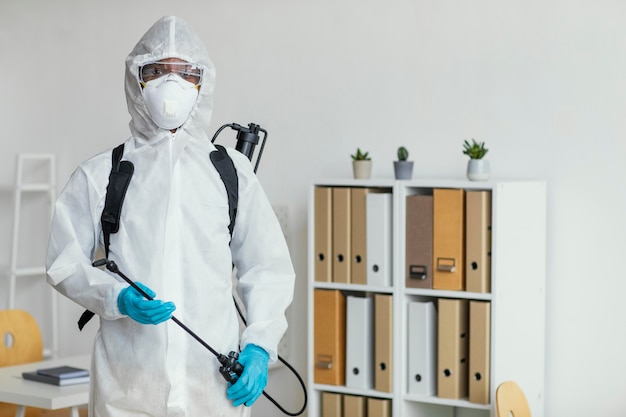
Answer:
[{"xmin": 46, "ymin": 17, "xmax": 295, "ymax": 417}]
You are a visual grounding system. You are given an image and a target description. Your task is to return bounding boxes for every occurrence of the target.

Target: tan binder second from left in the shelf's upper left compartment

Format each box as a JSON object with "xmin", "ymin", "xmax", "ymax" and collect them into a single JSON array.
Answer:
[{"xmin": 332, "ymin": 187, "xmax": 351, "ymax": 283}]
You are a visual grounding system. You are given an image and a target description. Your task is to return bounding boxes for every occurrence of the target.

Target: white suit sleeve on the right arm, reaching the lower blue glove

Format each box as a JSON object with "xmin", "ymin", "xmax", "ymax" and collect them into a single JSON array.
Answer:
[{"xmin": 231, "ymin": 150, "xmax": 295, "ymax": 362}]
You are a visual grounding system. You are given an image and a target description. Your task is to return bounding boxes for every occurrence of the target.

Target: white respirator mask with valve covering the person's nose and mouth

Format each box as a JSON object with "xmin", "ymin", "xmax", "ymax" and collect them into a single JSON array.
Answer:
[{"xmin": 142, "ymin": 74, "xmax": 198, "ymax": 130}]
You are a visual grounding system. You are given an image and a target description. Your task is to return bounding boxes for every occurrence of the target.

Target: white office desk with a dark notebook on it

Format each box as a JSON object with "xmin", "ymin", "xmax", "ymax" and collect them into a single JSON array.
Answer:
[{"xmin": 0, "ymin": 355, "xmax": 90, "ymax": 417}]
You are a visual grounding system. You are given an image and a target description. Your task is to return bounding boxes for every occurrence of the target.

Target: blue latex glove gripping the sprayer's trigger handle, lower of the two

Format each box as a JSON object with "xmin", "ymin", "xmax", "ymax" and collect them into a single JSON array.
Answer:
[{"xmin": 226, "ymin": 345, "xmax": 270, "ymax": 407}]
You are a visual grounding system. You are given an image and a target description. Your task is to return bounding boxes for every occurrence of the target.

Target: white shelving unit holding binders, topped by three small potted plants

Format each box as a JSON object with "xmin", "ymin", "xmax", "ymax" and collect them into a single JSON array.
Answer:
[{"xmin": 307, "ymin": 179, "xmax": 546, "ymax": 417}]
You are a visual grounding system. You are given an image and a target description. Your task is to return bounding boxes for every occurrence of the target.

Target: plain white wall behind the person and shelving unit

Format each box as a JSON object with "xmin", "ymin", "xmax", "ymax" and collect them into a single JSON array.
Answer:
[{"xmin": 0, "ymin": 0, "xmax": 626, "ymax": 417}]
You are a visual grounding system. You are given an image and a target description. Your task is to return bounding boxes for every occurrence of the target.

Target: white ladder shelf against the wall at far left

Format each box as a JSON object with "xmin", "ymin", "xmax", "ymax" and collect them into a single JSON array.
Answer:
[{"xmin": 8, "ymin": 154, "xmax": 58, "ymax": 357}]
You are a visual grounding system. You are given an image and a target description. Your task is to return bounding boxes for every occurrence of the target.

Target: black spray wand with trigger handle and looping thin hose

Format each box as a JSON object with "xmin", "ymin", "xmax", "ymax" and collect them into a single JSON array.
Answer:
[{"xmin": 92, "ymin": 259, "xmax": 307, "ymax": 416}]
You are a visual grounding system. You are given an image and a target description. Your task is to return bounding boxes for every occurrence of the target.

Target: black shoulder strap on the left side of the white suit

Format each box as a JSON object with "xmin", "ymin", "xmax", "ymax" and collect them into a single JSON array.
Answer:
[{"xmin": 78, "ymin": 143, "xmax": 135, "ymax": 330}]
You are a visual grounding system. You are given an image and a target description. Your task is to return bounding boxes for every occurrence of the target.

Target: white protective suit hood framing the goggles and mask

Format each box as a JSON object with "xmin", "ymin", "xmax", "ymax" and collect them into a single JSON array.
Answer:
[{"xmin": 125, "ymin": 16, "xmax": 215, "ymax": 141}]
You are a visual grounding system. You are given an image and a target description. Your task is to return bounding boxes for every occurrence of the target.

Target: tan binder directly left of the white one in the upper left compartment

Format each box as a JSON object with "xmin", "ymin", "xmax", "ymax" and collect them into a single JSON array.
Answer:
[{"xmin": 350, "ymin": 187, "xmax": 384, "ymax": 285}]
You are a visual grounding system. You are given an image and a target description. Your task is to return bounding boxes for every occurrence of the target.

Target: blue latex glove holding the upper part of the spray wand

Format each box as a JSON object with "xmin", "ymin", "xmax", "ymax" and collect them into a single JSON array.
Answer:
[{"xmin": 117, "ymin": 282, "xmax": 176, "ymax": 324}]
